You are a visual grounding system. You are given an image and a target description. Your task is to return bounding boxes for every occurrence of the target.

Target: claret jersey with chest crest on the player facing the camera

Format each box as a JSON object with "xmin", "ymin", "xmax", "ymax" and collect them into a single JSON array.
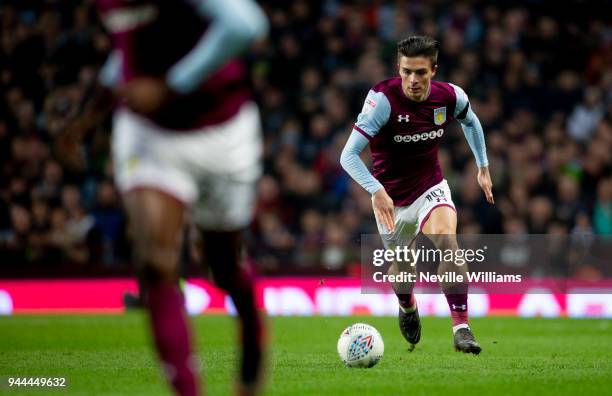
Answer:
[{"xmin": 355, "ymin": 77, "xmax": 467, "ymax": 206}]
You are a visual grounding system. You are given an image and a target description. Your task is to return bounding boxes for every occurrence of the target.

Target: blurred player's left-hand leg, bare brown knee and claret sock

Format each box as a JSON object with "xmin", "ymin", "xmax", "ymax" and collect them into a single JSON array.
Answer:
[{"xmin": 125, "ymin": 189, "xmax": 200, "ymax": 395}]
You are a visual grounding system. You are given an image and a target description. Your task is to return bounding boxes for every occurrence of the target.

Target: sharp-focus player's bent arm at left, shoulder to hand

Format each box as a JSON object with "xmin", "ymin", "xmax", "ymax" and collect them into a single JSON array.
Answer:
[{"xmin": 340, "ymin": 91, "xmax": 395, "ymax": 231}]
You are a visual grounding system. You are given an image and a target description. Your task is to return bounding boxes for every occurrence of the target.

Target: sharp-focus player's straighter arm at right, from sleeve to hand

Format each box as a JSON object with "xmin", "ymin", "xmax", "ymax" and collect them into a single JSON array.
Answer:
[{"xmin": 451, "ymin": 84, "xmax": 495, "ymax": 204}]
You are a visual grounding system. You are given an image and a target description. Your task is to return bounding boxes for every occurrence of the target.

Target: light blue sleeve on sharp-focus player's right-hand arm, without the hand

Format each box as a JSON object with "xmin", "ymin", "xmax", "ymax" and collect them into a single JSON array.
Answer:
[{"xmin": 450, "ymin": 84, "xmax": 489, "ymax": 167}]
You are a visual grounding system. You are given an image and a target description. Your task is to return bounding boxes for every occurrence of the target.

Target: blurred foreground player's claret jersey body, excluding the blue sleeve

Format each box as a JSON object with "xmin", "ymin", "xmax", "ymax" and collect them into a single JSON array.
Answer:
[{"xmin": 97, "ymin": 0, "xmax": 251, "ymax": 130}]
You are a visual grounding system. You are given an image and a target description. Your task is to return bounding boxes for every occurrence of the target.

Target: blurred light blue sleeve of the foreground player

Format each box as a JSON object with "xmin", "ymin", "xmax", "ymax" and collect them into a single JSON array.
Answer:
[{"xmin": 166, "ymin": 0, "xmax": 268, "ymax": 93}]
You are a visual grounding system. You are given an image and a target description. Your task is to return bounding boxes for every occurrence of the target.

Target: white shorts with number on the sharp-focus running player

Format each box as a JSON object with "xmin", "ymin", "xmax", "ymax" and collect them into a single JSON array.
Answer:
[{"xmin": 376, "ymin": 179, "xmax": 456, "ymax": 247}]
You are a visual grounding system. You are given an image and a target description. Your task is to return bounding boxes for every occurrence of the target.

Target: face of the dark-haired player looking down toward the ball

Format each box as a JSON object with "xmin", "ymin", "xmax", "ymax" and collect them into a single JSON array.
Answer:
[{"xmin": 397, "ymin": 56, "xmax": 438, "ymax": 102}]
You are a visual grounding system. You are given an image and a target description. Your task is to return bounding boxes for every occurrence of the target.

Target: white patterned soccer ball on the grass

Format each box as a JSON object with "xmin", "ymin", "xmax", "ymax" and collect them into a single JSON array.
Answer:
[{"xmin": 338, "ymin": 323, "xmax": 385, "ymax": 368}]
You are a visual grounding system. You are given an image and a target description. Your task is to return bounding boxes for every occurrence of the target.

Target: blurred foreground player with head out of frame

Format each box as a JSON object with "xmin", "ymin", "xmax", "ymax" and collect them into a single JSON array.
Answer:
[{"xmin": 92, "ymin": 0, "xmax": 268, "ymax": 395}]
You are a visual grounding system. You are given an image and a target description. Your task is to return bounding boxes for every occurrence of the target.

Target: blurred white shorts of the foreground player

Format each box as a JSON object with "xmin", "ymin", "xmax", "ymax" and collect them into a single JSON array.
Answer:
[{"xmin": 112, "ymin": 103, "xmax": 262, "ymax": 231}]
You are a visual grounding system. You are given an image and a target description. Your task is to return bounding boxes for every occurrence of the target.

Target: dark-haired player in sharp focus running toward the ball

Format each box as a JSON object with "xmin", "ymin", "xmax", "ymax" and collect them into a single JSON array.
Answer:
[{"xmin": 340, "ymin": 36, "xmax": 494, "ymax": 354}]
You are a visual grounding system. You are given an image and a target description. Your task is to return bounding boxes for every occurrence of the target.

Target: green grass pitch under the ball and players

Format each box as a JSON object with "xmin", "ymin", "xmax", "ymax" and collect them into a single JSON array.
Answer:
[{"xmin": 0, "ymin": 313, "xmax": 612, "ymax": 396}]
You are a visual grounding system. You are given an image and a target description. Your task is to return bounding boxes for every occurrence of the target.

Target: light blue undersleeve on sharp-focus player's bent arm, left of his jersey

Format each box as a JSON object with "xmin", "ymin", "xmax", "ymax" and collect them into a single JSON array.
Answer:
[{"xmin": 340, "ymin": 129, "xmax": 383, "ymax": 194}]
